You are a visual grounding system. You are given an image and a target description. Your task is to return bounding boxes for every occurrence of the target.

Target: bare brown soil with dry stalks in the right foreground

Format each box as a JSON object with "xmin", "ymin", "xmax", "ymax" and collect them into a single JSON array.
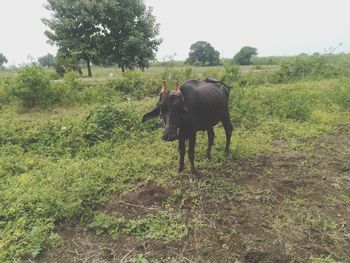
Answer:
[{"xmin": 27, "ymin": 134, "xmax": 350, "ymax": 263}]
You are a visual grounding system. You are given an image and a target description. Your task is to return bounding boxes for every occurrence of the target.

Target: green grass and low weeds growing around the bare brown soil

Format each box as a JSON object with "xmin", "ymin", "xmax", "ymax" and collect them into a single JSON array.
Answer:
[{"xmin": 0, "ymin": 68, "xmax": 350, "ymax": 262}]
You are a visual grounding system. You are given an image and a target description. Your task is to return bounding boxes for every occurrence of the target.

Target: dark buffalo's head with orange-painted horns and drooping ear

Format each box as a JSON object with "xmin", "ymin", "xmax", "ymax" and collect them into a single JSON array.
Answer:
[{"xmin": 142, "ymin": 81, "xmax": 187, "ymax": 141}]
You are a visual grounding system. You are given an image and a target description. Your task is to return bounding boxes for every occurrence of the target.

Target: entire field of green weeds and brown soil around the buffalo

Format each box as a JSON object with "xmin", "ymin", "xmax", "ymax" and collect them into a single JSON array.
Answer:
[{"xmin": 0, "ymin": 60, "xmax": 350, "ymax": 263}]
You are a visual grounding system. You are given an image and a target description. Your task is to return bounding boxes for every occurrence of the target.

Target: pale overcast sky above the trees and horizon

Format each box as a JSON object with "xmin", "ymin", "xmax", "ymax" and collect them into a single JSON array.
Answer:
[{"xmin": 0, "ymin": 0, "xmax": 350, "ymax": 65}]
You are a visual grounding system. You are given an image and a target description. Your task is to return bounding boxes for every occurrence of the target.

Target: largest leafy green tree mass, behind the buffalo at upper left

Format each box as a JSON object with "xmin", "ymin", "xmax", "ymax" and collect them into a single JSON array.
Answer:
[{"xmin": 43, "ymin": 0, "xmax": 161, "ymax": 76}]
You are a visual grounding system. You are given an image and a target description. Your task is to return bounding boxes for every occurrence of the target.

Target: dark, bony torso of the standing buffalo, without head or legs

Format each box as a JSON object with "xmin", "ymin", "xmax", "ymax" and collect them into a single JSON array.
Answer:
[{"xmin": 180, "ymin": 80, "xmax": 229, "ymax": 130}]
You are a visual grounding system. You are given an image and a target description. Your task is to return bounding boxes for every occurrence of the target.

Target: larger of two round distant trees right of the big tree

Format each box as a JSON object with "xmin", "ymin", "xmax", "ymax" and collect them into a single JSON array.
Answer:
[{"xmin": 186, "ymin": 41, "xmax": 220, "ymax": 66}]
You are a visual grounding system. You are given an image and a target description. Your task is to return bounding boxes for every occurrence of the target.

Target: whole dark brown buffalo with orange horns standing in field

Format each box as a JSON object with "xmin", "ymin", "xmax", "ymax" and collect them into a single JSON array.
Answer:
[{"xmin": 142, "ymin": 79, "xmax": 232, "ymax": 175}]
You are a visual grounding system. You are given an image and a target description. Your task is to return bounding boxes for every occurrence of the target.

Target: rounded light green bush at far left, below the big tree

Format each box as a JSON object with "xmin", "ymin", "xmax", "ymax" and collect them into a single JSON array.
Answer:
[{"xmin": 8, "ymin": 65, "xmax": 53, "ymax": 108}]
